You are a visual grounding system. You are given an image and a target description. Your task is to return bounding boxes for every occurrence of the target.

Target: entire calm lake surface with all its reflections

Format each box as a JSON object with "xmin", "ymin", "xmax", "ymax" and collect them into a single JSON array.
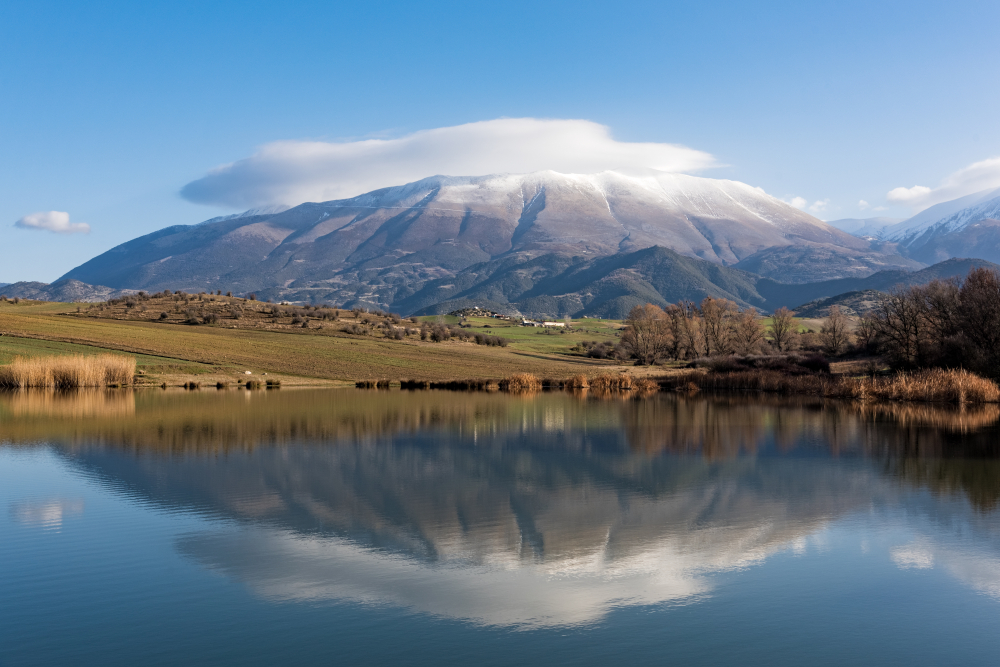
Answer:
[{"xmin": 0, "ymin": 389, "xmax": 1000, "ymax": 666}]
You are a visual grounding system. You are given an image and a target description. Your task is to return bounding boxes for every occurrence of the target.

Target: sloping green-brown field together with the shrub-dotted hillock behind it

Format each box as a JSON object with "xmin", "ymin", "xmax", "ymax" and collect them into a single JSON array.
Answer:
[{"xmin": 0, "ymin": 293, "xmax": 844, "ymax": 384}]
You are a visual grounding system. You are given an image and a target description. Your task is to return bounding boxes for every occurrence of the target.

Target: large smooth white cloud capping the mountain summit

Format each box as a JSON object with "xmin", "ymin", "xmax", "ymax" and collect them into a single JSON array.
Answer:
[{"xmin": 181, "ymin": 118, "xmax": 716, "ymax": 208}]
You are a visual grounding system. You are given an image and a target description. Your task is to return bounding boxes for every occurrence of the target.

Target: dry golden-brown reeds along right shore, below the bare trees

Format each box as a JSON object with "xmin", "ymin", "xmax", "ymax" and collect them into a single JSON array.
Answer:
[{"xmin": 661, "ymin": 369, "xmax": 1000, "ymax": 404}]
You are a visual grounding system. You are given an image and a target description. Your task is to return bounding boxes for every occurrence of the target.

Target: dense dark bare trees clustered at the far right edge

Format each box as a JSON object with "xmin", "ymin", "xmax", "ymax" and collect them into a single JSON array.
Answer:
[{"xmin": 855, "ymin": 268, "xmax": 1000, "ymax": 377}]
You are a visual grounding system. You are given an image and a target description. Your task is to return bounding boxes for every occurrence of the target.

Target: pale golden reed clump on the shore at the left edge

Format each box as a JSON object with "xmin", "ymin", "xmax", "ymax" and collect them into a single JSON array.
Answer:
[{"xmin": 0, "ymin": 354, "xmax": 135, "ymax": 389}]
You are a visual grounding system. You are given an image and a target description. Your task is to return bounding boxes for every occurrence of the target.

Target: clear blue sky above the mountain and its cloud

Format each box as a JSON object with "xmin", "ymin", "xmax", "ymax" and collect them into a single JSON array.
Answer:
[{"xmin": 0, "ymin": 0, "xmax": 1000, "ymax": 282}]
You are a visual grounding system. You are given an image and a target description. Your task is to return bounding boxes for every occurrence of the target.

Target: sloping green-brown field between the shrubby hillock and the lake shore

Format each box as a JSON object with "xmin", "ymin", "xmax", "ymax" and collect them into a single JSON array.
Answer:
[{"xmin": 0, "ymin": 300, "xmax": 625, "ymax": 384}]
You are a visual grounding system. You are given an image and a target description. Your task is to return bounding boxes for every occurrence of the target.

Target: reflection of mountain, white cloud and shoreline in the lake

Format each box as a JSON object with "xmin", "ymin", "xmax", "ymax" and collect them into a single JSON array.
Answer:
[{"xmin": 0, "ymin": 390, "xmax": 1000, "ymax": 627}]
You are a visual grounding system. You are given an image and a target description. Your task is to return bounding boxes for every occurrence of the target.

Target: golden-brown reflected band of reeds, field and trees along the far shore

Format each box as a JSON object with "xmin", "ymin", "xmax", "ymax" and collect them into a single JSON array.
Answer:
[{"xmin": 0, "ymin": 389, "xmax": 1000, "ymax": 459}]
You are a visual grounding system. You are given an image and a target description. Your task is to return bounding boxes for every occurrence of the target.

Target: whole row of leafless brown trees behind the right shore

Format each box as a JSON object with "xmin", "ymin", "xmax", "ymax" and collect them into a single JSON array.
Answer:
[{"xmin": 619, "ymin": 268, "xmax": 1000, "ymax": 370}]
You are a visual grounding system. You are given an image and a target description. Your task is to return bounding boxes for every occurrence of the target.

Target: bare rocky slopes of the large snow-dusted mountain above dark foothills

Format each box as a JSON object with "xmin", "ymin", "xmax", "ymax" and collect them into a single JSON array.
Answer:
[{"xmin": 63, "ymin": 172, "xmax": 918, "ymax": 312}]
